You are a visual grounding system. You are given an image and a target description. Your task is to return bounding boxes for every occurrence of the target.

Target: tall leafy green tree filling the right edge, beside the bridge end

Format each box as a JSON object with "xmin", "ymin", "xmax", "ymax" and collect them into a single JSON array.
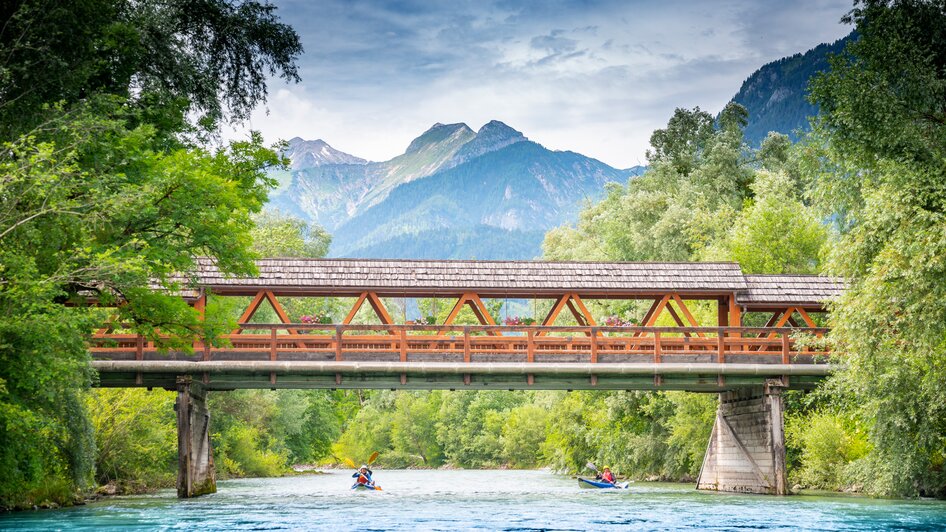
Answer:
[{"xmin": 806, "ymin": 1, "xmax": 946, "ymax": 496}]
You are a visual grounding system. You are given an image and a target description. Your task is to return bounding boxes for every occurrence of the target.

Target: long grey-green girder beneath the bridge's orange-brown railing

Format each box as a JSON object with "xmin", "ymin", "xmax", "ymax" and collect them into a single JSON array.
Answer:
[{"xmin": 93, "ymin": 360, "xmax": 830, "ymax": 392}]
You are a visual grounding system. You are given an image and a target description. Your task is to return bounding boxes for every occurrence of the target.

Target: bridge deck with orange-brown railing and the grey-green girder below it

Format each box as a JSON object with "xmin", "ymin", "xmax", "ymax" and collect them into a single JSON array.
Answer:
[{"xmin": 91, "ymin": 324, "xmax": 830, "ymax": 391}]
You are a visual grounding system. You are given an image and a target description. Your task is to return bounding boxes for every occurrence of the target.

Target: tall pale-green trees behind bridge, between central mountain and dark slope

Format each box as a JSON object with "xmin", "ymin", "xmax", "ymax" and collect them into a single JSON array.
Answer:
[{"xmin": 542, "ymin": 103, "xmax": 754, "ymax": 261}]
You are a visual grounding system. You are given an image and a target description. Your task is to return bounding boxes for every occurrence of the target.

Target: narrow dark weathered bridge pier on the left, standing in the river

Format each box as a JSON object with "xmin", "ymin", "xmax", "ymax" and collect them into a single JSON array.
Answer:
[{"xmin": 174, "ymin": 375, "xmax": 217, "ymax": 499}]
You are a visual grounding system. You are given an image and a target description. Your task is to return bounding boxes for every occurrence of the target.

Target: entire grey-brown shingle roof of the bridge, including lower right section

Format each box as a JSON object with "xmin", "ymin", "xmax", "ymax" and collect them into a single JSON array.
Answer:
[{"xmin": 170, "ymin": 258, "xmax": 844, "ymax": 309}]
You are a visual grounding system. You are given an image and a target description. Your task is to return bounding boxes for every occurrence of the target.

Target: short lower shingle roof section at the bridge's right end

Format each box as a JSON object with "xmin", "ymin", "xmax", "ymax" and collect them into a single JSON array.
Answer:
[{"xmin": 736, "ymin": 274, "xmax": 844, "ymax": 307}]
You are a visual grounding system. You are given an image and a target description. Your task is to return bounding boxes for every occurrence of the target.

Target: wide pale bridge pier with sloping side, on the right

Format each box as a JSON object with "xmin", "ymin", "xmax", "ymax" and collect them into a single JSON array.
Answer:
[{"xmin": 696, "ymin": 379, "xmax": 788, "ymax": 495}]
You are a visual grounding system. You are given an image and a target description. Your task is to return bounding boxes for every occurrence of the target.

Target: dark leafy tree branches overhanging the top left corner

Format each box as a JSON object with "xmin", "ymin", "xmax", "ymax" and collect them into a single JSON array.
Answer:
[{"xmin": 0, "ymin": 0, "xmax": 302, "ymax": 140}]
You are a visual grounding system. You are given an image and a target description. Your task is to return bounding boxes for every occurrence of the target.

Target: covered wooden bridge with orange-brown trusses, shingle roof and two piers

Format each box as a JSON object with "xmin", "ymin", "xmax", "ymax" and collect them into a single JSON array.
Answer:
[{"xmin": 91, "ymin": 259, "xmax": 843, "ymax": 496}]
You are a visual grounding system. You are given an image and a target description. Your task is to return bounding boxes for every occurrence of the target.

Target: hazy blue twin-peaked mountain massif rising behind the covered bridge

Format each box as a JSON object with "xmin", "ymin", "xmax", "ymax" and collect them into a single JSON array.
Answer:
[{"xmin": 271, "ymin": 120, "xmax": 642, "ymax": 259}]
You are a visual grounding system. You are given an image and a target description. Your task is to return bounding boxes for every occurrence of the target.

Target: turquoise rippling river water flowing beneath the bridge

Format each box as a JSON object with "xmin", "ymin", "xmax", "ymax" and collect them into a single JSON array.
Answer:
[{"xmin": 0, "ymin": 470, "xmax": 946, "ymax": 530}]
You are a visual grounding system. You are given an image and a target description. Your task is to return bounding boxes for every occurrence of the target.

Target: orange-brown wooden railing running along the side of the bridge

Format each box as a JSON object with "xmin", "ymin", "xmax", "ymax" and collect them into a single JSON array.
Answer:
[{"xmin": 91, "ymin": 323, "xmax": 829, "ymax": 364}]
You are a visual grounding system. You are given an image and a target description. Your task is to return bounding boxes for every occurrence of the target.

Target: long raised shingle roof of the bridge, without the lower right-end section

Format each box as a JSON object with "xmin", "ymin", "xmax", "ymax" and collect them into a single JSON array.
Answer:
[{"xmin": 179, "ymin": 259, "xmax": 746, "ymax": 297}]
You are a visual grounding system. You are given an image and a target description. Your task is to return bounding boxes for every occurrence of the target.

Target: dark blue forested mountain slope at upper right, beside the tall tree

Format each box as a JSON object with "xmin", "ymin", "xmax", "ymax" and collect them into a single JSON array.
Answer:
[{"xmin": 732, "ymin": 33, "xmax": 855, "ymax": 147}]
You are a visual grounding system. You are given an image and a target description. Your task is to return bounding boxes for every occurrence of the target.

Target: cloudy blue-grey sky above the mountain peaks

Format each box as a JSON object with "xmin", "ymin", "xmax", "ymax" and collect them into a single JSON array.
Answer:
[{"xmin": 227, "ymin": 0, "xmax": 851, "ymax": 168}]
